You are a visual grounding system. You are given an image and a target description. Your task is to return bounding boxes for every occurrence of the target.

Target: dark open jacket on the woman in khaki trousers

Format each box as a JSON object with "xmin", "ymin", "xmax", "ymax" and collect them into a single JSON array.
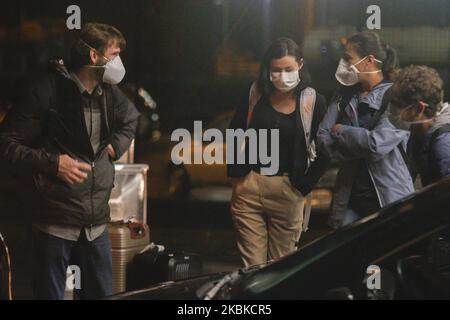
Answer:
[{"xmin": 227, "ymin": 84, "xmax": 330, "ymax": 196}]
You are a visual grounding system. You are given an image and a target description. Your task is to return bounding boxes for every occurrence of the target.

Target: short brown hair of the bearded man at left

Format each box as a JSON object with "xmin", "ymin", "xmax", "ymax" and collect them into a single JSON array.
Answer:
[{"xmin": 68, "ymin": 22, "xmax": 126, "ymax": 71}]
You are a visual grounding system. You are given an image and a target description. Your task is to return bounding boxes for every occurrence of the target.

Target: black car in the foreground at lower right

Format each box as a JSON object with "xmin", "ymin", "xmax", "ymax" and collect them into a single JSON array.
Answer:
[{"xmin": 110, "ymin": 178, "xmax": 450, "ymax": 300}]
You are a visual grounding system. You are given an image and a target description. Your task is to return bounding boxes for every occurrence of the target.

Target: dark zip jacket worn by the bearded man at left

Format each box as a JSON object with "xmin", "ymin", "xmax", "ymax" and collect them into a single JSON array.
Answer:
[{"xmin": 0, "ymin": 65, "xmax": 139, "ymax": 226}]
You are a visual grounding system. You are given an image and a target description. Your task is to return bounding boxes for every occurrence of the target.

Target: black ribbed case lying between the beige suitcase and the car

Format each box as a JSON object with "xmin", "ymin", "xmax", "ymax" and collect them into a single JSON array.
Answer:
[{"xmin": 127, "ymin": 243, "xmax": 203, "ymax": 291}]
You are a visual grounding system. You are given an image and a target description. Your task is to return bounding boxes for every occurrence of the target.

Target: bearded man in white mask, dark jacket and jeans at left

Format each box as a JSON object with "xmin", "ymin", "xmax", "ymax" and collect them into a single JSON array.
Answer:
[{"xmin": 0, "ymin": 23, "xmax": 139, "ymax": 299}]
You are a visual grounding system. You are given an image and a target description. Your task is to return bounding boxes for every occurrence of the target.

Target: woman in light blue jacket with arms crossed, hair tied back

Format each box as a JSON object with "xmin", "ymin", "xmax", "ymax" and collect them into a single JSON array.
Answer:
[{"xmin": 317, "ymin": 32, "xmax": 414, "ymax": 228}]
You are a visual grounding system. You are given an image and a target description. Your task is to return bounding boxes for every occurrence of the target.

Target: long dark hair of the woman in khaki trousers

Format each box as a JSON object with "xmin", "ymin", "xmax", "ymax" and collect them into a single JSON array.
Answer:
[{"xmin": 256, "ymin": 38, "xmax": 311, "ymax": 97}]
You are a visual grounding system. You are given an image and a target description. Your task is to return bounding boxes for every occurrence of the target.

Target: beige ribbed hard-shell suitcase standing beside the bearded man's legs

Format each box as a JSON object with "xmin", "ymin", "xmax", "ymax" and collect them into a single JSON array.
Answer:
[{"xmin": 109, "ymin": 222, "xmax": 150, "ymax": 293}]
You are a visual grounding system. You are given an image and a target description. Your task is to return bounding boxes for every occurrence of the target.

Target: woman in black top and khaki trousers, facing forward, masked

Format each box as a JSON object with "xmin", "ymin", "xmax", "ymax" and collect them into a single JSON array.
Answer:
[{"xmin": 228, "ymin": 38, "xmax": 327, "ymax": 266}]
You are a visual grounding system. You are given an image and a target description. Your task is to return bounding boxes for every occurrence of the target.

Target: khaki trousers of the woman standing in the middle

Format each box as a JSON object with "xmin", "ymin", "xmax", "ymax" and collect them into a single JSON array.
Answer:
[{"xmin": 231, "ymin": 171, "xmax": 305, "ymax": 266}]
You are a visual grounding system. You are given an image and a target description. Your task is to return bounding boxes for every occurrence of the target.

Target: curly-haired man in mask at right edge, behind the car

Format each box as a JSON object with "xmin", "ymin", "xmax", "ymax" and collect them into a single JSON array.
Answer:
[{"xmin": 389, "ymin": 66, "xmax": 450, "ymax": 186}]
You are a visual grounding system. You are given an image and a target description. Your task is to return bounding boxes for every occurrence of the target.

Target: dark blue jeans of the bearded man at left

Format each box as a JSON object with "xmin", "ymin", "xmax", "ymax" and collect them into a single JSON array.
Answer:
[{"xmin": 33, "ymin": 228, "xmax": 112, "ymax": 300}]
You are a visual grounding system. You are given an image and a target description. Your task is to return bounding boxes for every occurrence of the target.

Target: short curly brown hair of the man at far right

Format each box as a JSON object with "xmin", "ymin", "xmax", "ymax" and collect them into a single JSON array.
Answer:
[{"xmin": 393, "ymin": 65, "xmax": 444, "ymax": 118}]
